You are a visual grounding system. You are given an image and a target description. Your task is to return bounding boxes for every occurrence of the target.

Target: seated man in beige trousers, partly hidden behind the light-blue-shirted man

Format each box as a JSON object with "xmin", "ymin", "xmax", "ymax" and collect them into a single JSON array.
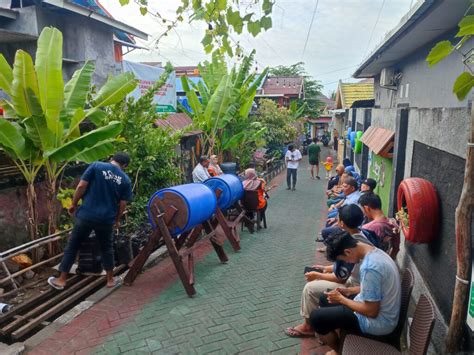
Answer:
[{"xmin": 285, "ymin": 205, "xmax": 371, "ymax": 337}]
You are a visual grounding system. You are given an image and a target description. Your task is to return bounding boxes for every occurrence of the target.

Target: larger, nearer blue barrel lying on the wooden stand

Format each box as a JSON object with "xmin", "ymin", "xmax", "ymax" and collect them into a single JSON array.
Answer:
[{"xmin": 148, "ymin": 184, "xmax": 217, "ymax": 235}]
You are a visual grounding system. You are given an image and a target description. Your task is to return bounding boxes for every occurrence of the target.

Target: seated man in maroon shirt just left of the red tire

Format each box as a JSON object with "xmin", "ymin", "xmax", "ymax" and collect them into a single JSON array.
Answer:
[{"xmin": 359, "ymin": 192, "xmax": 400, "ymax": 259}]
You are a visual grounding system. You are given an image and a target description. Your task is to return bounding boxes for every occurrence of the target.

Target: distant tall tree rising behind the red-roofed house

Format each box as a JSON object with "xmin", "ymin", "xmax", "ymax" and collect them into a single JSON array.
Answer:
[{"xmin": 269, "ymin": 62, "xmax": 323, "ymax": 117}]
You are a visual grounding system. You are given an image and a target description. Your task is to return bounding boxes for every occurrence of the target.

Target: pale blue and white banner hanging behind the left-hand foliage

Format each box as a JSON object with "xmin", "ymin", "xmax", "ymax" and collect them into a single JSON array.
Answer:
[{"xmin": 123, "ymin": 60, "xmax": 176, "ymax": 113}]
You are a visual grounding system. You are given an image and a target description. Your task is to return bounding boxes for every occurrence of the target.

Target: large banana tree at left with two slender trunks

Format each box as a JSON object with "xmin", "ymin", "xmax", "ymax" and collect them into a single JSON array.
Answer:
[{"xmin": 0, "ymin": 27, "xmax": 137, "ymax": 243}]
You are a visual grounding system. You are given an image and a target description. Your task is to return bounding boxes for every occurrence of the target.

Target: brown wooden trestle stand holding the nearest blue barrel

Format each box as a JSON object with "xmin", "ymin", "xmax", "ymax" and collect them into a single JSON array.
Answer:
[{"xmin": 124, "ymin": 199, "xmax": 230, "ymax": 297}]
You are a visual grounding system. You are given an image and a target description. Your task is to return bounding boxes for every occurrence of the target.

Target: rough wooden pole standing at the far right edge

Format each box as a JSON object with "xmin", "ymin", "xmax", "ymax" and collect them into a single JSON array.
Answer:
[{"xmin": 446, "ymin": 105, "xmax": 474, "ymax": 353}]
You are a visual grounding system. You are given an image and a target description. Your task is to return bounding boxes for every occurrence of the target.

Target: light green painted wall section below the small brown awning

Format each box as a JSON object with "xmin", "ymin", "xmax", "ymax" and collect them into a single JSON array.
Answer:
[{"xmin": 369, "ymin": 152, "xmax": 392, "ymax": 215}]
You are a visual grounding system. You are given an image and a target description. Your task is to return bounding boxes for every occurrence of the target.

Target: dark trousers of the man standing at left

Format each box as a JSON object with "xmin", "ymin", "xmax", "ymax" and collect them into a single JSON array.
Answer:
[{"xmin": 59, "ymin": 218, "xmax": 114, "ymax": 272}]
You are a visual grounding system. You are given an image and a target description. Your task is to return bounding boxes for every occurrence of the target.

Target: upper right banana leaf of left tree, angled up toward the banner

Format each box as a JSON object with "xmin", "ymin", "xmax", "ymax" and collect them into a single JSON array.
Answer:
[{"xmin": 92, "ymin": 72, "xmax": 138, "ymax": 107}]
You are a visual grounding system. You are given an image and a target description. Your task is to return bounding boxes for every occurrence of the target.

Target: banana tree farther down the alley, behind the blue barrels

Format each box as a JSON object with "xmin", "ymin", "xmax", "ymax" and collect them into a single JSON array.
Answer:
[{"xmin": 181, "ymin": 51, "xmax": 268, "ymax": 161}]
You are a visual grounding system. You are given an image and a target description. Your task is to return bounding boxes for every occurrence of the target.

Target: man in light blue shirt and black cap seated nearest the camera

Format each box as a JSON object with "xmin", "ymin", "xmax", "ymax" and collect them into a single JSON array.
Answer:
[{"xmin": 310, "ymin": 231, "xmax": 401, "ymax": 353}]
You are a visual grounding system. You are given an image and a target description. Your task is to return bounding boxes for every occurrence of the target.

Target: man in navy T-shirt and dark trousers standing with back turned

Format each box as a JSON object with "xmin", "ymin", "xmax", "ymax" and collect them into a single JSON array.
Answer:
[{"xmin": 48, "ymin": 153, "xmax": 132, "ymax": 290}]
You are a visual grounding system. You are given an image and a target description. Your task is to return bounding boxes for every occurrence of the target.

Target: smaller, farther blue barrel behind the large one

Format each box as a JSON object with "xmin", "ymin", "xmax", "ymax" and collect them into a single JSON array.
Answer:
[{"xmin": 204, "ymin": 174, "xmax": 244, "ymax": 211}]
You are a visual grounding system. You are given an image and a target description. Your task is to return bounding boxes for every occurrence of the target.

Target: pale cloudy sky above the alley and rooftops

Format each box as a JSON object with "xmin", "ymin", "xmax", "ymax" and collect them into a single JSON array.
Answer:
[{"xmin": 106, "ymin": 0, "xmax": 416, "ymax": 95}]
